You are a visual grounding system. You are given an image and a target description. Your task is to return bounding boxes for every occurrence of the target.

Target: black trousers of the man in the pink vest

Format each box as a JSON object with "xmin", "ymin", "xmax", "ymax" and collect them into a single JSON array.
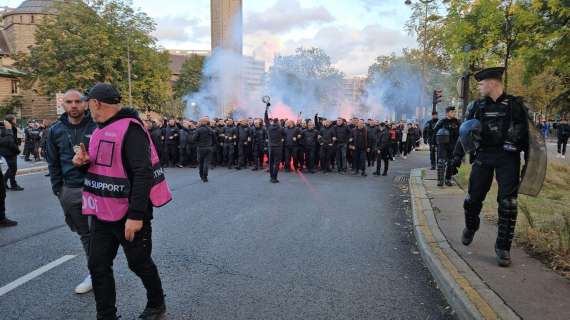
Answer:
[{"xmin": 88, "ymin": 217, "xmax": 164, "ymax": 320}]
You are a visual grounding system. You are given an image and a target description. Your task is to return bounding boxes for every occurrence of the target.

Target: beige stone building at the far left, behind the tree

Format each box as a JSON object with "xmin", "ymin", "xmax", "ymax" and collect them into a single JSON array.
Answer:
[{"xmin": 0, "ymin": 0, "xmax": 64, "ymax": 120}]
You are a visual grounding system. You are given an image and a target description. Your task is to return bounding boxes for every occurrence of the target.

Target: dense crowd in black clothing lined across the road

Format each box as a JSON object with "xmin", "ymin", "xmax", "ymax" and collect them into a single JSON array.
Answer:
[{"xmin": 141, "ymin": 115, "xmax": 422, "ymax": 180}]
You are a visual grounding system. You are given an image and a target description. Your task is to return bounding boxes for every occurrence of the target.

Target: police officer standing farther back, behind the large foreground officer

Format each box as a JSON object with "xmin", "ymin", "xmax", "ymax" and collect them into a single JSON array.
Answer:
[{"xmin": 433, "ymin": 107, "xmax": 459, "ymax": 187}]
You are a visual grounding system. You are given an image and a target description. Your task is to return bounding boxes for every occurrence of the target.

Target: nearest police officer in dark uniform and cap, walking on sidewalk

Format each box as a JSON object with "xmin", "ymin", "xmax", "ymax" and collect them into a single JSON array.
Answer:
[{"xmin": 455, "ymin": 68, "xmax": 529, "ymax": 267}]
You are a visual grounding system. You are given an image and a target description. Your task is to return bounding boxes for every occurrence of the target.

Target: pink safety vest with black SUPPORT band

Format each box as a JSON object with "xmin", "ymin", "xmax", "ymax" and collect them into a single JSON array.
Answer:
[{"xmin": 83, "ymin": 118, "xmax": 172, "ymax": 221}]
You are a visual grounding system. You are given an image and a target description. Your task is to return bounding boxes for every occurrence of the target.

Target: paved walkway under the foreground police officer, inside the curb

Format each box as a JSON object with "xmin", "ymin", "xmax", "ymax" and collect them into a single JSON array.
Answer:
[{"xmin": 422, "ymin": 170, "xmax": 570, "ymax": 320}]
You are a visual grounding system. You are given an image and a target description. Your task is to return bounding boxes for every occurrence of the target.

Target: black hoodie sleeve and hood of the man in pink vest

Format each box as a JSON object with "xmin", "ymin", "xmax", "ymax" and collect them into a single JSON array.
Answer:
[{"xmin": 98, "ymin": 108, "xmax": 154, "ymax": 220}]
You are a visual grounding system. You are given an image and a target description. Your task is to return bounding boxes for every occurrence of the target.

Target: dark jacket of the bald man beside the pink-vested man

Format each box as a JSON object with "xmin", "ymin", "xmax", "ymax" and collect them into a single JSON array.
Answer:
[{"xmin": 46, "ymin": 113, "xmax": 95, "ymax": 195}]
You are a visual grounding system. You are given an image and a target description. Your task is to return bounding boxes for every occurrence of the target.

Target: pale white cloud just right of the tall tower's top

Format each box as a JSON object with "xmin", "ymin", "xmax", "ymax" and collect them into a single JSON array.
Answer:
[{"xmin": 245, "ymin": 0, "xmax": 335, "ymax": 33}]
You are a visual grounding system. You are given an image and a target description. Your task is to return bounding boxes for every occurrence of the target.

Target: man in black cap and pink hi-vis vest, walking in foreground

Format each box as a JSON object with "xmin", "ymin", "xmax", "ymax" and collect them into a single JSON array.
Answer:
[{"xmin": 73, "ymin": 83, "xmax": 172, "ymax": 320}]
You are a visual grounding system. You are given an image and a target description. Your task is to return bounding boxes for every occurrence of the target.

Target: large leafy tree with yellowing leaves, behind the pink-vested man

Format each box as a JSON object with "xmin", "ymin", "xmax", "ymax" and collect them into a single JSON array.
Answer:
[{"xmin": 16, "ymin": 0, "xmax": 175, "ymax": 112}]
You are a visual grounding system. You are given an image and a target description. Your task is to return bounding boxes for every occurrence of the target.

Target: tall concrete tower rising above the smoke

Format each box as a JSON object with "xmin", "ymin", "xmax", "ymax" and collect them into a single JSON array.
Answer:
[{"xmin": 210, "ymin": 0, "xmax": 243, "ymax": 55}]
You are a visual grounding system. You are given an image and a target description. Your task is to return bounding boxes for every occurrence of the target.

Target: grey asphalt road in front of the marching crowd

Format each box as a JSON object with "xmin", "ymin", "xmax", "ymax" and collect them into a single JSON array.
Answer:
[{"xmin": 0, "ymin": 153, "xmax": 453, "ymax": 320}]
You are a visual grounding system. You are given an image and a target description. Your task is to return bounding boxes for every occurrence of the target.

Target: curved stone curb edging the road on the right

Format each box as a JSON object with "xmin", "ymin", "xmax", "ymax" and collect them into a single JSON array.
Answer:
[{"xmin": 410, "ymin": 168, "xmax": 520, "ymax": 320}]
